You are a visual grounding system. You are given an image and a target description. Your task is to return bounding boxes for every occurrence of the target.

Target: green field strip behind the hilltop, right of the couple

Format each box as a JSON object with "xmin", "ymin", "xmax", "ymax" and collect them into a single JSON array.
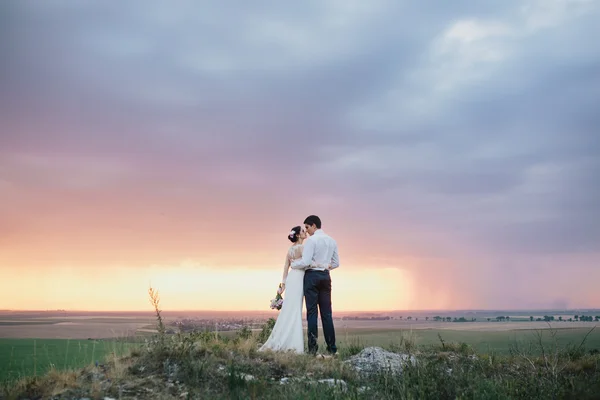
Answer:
[{"xmin": 336, "ymin": 326, "xmax": 600, "ymax": 354}]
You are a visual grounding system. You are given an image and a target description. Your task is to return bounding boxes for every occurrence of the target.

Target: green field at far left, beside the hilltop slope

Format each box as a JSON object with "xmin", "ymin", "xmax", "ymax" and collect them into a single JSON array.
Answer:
[{"xmin": 0, "ymin": 339, "xmax": 137, "ymax": 382}]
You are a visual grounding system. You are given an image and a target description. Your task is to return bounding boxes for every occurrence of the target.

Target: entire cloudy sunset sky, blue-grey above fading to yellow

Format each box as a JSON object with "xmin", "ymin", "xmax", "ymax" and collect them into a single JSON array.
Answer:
[{"xmin": 0, "ymin": 0, "xmax": 600, "ymax": 312}]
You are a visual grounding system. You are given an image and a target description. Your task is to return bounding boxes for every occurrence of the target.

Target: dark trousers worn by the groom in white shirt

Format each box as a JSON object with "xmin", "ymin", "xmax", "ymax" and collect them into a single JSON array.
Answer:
[{"xmin": 304, "ymin": 270, "xmax": 337, "ymax": 354}]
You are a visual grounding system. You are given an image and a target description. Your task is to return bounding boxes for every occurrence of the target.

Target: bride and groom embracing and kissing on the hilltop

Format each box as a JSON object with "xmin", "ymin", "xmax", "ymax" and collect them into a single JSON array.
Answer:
[{"xmin": 260, "ymin": 215, "xmax": 340, "ymax": 355}]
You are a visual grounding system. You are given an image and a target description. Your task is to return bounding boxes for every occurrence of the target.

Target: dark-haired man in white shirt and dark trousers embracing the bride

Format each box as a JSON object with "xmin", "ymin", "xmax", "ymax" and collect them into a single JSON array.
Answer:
[{"xmin": 290, "ymin": 215, "xmax": 340, "ymax": 355}]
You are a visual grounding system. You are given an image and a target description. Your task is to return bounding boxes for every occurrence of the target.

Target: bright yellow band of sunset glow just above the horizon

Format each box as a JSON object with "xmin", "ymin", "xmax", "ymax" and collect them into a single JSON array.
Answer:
[{"xmin": 0, "ymin": 263, "xmax": 420, "ymax": 311}]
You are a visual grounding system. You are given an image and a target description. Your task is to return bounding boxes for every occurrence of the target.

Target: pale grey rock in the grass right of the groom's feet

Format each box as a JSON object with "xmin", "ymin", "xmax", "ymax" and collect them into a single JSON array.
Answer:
[{"xmin": 344, "ymin": 347, "xmax": 417, "ymax": 375}]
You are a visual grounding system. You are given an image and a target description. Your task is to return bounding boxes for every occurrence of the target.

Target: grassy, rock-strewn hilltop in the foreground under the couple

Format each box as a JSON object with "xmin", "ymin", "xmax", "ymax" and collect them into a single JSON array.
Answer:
[{"xmin": 0, "ymin": 317, "xmax": 600, "ymax": 399}]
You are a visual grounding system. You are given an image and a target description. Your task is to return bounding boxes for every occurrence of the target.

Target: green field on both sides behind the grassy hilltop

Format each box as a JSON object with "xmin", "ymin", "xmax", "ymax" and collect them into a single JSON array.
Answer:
[{"xmin": 0, "ymin": 328, "xmax": 600, "ymax": 381}]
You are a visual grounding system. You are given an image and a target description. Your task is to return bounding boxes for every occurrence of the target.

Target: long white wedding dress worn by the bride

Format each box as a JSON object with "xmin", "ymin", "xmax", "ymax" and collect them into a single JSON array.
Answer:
[{"xmin": 259, "ymin": 245, "xmax": 304, "ymax": 354}]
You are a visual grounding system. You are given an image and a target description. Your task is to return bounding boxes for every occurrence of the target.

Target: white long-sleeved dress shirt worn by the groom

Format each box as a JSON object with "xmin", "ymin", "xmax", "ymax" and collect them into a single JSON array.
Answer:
[{"xmin": 290, "ymin": 229, "xmax": 340, "ymax": 271}]
